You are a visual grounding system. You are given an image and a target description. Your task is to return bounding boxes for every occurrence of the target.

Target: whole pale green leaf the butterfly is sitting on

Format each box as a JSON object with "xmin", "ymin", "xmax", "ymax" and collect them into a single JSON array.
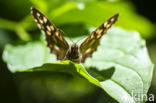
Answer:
[{"xmin": 3, "ymin": 28, "xmax": 153, "ymax": 103}]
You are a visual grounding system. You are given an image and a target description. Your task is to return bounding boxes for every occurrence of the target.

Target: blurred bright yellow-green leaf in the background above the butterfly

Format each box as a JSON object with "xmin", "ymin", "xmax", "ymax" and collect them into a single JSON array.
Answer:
[{"xmin": 48, "ymin": 1, "xmax": 155, "ymax": 38}]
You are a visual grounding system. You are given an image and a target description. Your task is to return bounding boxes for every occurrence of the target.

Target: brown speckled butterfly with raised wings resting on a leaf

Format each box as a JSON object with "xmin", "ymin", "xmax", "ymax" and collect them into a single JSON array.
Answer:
[{"xmin": 31, "ymin": 7, "xmax": 119, "ymax": 63}]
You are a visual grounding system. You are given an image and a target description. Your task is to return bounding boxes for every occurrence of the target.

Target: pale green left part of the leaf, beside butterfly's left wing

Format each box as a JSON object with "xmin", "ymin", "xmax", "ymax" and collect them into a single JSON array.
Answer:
[{"xmin": 3, "ymin": 42, "xmax": 56, "ymax": 72}]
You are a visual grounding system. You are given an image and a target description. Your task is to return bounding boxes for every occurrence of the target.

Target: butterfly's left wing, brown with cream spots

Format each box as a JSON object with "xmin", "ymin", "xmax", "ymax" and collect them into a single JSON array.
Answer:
[{"xmin": 31, "ymin": 8, "xmax": 69, "ymax": 60}]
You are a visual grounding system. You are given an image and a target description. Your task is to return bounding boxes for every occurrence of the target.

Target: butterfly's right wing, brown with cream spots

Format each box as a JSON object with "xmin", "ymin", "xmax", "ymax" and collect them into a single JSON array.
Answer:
[{"xmin": 80, "ymin": 14, "xmax": 119, "ymax": 62}]
